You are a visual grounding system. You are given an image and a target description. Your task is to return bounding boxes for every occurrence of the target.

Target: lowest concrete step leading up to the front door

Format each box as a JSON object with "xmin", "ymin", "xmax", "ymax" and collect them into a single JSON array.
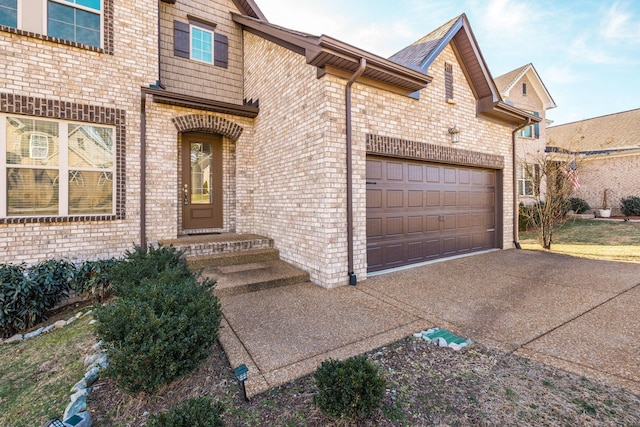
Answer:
[{"xmin": 202, "ymin": 260, "xmax": 309, "ymax": 296}]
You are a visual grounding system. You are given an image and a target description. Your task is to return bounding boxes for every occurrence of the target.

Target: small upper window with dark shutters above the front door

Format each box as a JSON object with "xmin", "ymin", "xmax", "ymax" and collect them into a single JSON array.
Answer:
[{"xmin": 174, "ymin": 17, "xmax": 229, "ymax": 68}]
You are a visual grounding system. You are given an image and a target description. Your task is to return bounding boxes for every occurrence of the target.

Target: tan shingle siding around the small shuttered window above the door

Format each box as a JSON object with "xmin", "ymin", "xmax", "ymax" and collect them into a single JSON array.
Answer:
[{"xmin": 160, "ymin": 0, "xmax": 243, "ymax": 104}]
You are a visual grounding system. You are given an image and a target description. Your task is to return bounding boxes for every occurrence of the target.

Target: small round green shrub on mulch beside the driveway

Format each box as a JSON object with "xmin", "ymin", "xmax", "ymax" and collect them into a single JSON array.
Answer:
[{"xmin": 313, "ymin": 356, "xmax": 385, "ymax": 419}]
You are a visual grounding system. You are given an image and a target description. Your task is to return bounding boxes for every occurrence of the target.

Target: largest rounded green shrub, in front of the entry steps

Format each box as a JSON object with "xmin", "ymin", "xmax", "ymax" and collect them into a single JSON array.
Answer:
[{"xmin": 94, "ymin": 267, "xmax": 222, "ymax": 393}]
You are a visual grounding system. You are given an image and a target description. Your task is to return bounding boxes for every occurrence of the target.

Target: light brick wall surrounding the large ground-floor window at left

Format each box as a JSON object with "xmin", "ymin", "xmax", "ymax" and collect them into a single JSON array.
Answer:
[{"xmin": 0, "ymin": 0, "xmax": 157, "ymax": 263}]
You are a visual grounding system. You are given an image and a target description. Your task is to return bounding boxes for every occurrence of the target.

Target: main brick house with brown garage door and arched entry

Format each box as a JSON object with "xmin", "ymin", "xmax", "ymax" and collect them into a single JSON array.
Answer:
[{"xmin": 0, "ymin": 0, "xmax": 540, "ymax": 287}]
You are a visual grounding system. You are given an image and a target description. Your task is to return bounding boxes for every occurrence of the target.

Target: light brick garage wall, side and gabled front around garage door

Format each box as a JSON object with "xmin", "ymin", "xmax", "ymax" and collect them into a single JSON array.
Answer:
[{"xmin": 238, "ymin": 34, "xmax": 513, "ymax": 287}]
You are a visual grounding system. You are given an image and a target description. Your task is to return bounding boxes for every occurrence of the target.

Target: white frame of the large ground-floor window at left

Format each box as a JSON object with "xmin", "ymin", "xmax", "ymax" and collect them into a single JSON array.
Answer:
[{"xmin": 0, "ymin": 113, "xmax": 117, "ymax": 219}]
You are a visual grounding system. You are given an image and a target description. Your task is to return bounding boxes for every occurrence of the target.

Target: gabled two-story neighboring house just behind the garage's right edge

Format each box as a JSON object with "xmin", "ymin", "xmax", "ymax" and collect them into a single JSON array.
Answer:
[{"xmin": 495, "ymin": 64, "xmax": 556, "ymax": 204}]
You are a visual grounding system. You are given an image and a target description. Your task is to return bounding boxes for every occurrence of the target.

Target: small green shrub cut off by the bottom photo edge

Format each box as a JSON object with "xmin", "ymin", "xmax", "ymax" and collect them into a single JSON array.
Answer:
[{"xmin": 146, "ymin": 397, "xmax": 224, "ymax": 427}]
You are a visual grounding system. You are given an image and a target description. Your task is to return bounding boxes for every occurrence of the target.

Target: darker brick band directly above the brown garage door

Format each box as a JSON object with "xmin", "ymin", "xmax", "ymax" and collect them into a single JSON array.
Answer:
[{"xmin": 367, "ymin": 134, "xmax": 504, "ymax": 169}]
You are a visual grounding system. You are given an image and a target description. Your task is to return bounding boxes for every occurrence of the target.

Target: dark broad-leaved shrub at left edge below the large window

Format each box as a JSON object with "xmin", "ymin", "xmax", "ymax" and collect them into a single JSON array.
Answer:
[{"xmin": 0, "ymin": 260, "xmax": 75, "ymax": 336}]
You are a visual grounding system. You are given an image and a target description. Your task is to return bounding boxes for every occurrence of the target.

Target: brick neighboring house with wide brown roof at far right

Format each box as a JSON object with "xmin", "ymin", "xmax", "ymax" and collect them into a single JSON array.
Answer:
[{"xmin": 547, "ymin": 109, "xmax": 640, "ymax": 215}]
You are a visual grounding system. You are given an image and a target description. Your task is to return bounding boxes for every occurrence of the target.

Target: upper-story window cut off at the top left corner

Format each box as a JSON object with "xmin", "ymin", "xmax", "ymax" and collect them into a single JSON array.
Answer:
[{"xmin": 0, "ymin": 0, "xmax": 107, "ymax": 48}]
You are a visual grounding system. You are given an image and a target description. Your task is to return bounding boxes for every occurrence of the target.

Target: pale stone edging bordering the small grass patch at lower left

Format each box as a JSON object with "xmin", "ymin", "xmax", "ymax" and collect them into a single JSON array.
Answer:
[{"xmin": 0, "ymin": 310, "xmax": 109, "ymax": 427}]
